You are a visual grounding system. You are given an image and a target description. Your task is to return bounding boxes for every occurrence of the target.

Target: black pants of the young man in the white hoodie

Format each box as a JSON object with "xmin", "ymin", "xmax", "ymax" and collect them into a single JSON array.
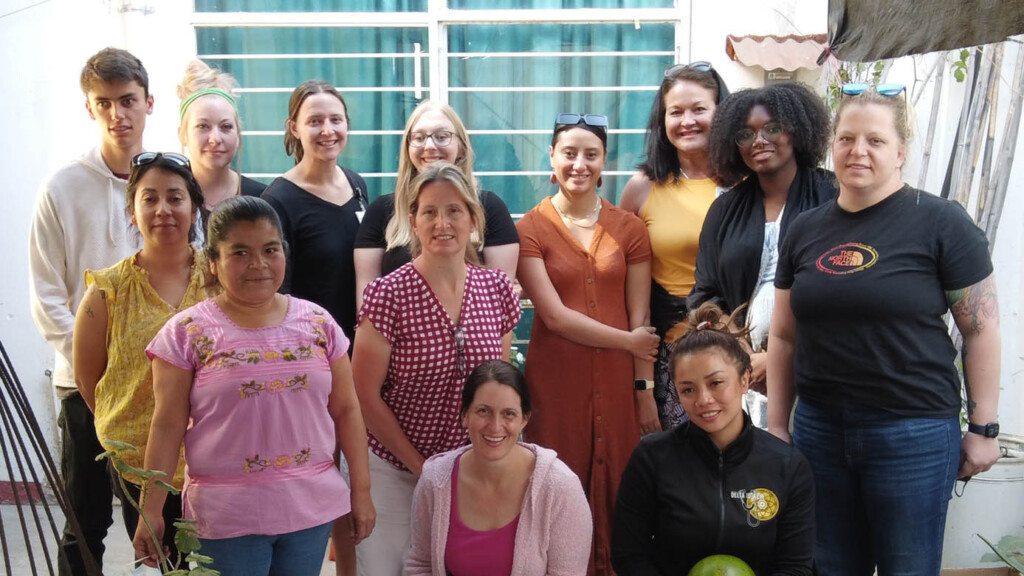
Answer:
[{"xmin": 57, "ymin": 393, "xmax": 114, "ymax": 576}]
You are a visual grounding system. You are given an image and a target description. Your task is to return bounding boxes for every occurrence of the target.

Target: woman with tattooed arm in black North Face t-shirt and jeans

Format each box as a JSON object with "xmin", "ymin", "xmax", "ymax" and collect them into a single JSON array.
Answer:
[{"xmin": 768, "ymin": 85, "xmax": 1000, "ymax": 576}]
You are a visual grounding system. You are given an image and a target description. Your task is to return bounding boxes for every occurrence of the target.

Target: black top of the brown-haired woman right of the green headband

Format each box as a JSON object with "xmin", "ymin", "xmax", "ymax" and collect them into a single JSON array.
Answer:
[{"xmin": 262, "ymin": 168, "xmax": 367, "ymax": 340}]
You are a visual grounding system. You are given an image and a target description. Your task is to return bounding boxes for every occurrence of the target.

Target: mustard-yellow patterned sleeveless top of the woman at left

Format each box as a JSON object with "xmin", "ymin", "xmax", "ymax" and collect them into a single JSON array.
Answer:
[{"xmin": 85, "ymin": 250, "xmax": 219, "ymax": 489}]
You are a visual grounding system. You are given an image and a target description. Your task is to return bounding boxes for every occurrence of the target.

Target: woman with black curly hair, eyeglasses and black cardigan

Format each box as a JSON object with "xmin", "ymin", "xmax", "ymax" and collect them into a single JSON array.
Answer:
[{"xmin": 687, "ymin": 83, "xmax": 837, "ymax": 405}]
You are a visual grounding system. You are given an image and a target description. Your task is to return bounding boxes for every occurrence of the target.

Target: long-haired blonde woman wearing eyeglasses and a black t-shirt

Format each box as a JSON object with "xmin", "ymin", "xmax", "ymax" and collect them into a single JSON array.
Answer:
[{"xmin": 355, "ymin": 100, "xmax": 519, "ymax": 307}]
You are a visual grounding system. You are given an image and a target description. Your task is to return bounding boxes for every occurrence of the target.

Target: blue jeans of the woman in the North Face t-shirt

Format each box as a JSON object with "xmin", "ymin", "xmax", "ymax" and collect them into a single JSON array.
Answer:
[{"xmin": 793, "ymin": 401, "xmax": 961, "ymax": 576}]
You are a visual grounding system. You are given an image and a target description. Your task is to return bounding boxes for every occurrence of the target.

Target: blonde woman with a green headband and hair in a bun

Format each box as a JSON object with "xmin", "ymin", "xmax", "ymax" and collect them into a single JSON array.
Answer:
[{"xmin": 177, "ymin": 60, "xmax": 266, "ymax": 230}]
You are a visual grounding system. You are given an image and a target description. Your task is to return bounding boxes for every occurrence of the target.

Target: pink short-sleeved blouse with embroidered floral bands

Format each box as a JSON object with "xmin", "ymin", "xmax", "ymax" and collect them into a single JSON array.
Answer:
[{"xmin": 146, "ymin": 296, "xmax": 350, "ymax": 539}]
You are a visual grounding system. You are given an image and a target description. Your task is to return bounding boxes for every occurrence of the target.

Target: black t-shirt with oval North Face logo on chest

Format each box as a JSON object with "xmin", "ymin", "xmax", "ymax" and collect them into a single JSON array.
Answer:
[{"xmin": 775, "ymin": 186, "xmax": 992, "ymax": 417}]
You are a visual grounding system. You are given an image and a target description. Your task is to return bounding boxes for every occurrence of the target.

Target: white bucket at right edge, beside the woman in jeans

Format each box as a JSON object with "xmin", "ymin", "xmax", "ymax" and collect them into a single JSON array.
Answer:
[{"xmin": 942, "ymin": 434, "xmax": 1024, "ymax": 568}]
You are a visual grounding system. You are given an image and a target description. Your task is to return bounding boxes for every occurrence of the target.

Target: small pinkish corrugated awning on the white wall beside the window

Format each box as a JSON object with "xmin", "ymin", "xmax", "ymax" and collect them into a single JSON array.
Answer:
[{"xmin": 725, "ymin": 34, "xmax": 827, "ymax": 72}]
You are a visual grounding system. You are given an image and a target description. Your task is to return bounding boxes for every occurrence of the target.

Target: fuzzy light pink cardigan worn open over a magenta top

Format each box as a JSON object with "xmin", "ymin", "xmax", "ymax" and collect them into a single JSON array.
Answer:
[{"xmin": 402, "ymin": 443, "xmax": 594, "ymax": 576}]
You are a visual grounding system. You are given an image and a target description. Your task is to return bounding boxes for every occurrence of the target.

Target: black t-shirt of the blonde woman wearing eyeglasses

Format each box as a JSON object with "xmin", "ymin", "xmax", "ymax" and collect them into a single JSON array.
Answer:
[{"xmin": 355, "ymin": 190, "xmax": 519, "ymax": 276}]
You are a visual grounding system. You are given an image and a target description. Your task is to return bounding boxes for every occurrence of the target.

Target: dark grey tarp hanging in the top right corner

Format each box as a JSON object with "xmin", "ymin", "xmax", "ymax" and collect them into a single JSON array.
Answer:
[{"xmin": 828, "ymin": 0, "xmax": 1024, "ymax": 61}]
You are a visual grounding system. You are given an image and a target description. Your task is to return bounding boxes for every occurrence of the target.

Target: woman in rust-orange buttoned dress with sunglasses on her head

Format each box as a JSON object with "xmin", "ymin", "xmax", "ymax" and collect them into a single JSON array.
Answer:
[{"xmin": 518, "ymin": 114, "xmax": 659, "ymax": 575}]
